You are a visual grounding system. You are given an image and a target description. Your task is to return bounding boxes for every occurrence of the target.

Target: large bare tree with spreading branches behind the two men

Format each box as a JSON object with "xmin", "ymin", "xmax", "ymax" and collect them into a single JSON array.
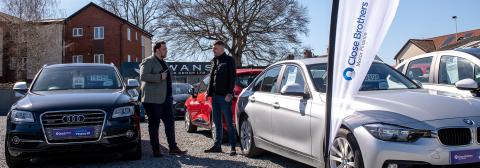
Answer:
[{"xmin": 157, "ymin": 0, "xmax": 309, "ymax": 66}]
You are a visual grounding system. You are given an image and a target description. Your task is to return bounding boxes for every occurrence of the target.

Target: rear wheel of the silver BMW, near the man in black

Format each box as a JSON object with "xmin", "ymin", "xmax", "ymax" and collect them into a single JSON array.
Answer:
[{"xmin": 240, "ymin": 117, "xmax": 263, "ymax": 158}]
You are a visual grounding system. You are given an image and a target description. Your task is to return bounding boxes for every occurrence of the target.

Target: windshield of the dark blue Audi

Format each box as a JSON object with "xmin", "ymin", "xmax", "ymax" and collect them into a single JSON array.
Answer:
[{"xmin": 32, "ymin": 67, "xmax": 122, "ymax": 91}]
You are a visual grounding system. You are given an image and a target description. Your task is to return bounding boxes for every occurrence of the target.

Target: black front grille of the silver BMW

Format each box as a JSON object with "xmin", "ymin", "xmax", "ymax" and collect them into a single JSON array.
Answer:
[{"xmin": 438, "ymin": 128, "xmax": 472, "ymax": 146}]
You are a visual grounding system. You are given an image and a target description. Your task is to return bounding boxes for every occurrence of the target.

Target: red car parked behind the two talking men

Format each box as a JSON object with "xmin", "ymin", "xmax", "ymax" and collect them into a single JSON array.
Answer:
[{"xmin": 185, "ymin": 69, "xmax": 263, "ymax": 140}]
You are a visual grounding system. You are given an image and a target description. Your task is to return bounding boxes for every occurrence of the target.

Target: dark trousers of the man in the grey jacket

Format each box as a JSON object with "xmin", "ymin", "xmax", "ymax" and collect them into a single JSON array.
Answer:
[{"xmin": 143, "ymin": 98, "xmax": 177, "ymax": 150}]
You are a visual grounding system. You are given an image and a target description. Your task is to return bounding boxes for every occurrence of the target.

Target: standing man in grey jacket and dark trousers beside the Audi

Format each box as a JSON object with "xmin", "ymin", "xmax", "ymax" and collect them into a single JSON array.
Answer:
[{"xmin": 140, "ymin": 41, "xmax": 187, "ymax": 157}]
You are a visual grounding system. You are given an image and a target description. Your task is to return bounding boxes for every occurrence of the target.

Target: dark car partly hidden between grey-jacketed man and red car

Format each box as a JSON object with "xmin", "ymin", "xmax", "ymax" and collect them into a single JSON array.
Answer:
[{"xmin": 172, "ymin": 83, "xmax": 193, "ymax": 117}]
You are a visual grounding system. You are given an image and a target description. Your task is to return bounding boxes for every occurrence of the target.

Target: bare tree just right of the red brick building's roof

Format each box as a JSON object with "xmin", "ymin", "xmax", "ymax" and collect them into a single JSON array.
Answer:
[{"xmin": 100, "ymin": 0, "xmax": 162, "ymax": 34}]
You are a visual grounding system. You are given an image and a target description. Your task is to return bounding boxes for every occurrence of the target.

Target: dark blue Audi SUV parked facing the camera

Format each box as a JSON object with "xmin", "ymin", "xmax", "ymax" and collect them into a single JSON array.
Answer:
[{"xmin": 5, "ymin": 64, "xmax": 142, "ymax": 167}]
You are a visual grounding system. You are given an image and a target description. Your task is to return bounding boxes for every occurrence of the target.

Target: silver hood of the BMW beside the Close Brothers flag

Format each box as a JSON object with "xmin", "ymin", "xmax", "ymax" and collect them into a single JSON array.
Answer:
[{"xmin": 350, "ymin": 89, "xmax": 480, "ymax": 124}]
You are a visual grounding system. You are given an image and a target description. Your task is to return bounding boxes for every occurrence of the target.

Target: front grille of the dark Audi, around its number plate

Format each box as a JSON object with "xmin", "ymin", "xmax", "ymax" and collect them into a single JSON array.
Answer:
[{"xmin": 40, "ymin": 110, "xmax": 106, "ymax": 143}]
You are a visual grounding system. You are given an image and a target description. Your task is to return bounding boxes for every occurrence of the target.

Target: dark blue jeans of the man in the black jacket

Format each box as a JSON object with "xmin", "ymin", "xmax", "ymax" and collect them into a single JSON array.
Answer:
[{"xmin": 212, "ymin": 96, "xmax": 237, "ymax": 148}]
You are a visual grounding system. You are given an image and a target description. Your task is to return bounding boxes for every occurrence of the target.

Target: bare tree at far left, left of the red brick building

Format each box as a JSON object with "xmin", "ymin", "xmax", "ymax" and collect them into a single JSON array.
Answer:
[{"xmin": 0, "ymin": 0, "xmax": 58, "ymax": 80}]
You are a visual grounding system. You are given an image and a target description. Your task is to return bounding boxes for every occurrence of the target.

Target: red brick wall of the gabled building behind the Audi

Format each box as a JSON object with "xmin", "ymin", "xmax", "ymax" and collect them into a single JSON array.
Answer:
[{"xmin": 64, "ymin": 6, "xmax": 147, "ymax": 67}]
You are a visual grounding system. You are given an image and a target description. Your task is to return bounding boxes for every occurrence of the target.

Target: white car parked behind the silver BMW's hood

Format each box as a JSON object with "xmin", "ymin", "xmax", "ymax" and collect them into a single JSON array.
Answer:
[{"xmin": 396, "ymin": 48, "xmax": 480, "ymax": 96}]
